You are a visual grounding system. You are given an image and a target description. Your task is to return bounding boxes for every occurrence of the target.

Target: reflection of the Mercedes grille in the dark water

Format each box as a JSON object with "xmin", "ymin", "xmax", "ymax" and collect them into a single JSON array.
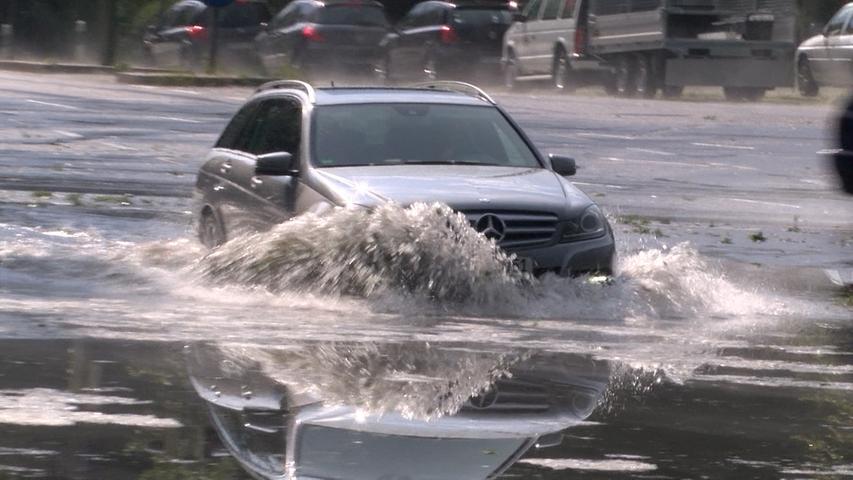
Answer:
[{"xmin": 462, "ymin": 379, "xmax": 551, "ymax": 413}]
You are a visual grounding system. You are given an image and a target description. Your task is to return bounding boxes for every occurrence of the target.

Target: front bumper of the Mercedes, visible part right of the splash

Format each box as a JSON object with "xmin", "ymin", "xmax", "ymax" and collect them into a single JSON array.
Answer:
[{"xmin": 510, "ymin": 229, "xmax": 616, "ymax": 276}]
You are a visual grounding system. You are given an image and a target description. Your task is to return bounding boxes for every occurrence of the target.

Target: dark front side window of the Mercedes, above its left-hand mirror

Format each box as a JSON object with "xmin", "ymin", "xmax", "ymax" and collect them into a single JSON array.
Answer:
[{"xmin": 237, "ymin": 98, "xmax": 302, "ymax": 157}]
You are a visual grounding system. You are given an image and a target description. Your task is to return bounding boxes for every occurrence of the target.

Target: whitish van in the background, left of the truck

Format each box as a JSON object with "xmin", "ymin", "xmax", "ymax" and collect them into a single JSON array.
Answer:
[{"xmin": 503, "ymin": 0, "xmax": 610, "ymax": 91}]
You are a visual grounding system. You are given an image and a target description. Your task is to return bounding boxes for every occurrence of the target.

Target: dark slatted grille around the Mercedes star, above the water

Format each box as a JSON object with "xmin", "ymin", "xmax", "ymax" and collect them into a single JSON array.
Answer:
[{"xmin": 462, "ymin": 210, "xmax": 559, "ymax": 251}]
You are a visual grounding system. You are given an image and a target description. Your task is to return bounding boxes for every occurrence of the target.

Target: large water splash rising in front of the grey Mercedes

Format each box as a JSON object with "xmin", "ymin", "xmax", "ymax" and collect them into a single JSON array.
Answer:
[{"xmin": 197, "ymin": 204, "xmax": 528, "ymax": 303}]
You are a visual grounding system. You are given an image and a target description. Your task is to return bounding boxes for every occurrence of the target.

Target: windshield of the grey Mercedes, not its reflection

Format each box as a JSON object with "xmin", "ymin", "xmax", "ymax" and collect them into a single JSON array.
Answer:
[{"xmin": 313, "ymin": 103, "xmax": 541, "ymax": 168}]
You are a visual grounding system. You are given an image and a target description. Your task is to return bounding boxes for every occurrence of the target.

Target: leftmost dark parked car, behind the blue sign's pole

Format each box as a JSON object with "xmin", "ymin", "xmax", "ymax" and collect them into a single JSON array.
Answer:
[{"xmin": 143, "ymin": 0, "xmax": 271, "ymax": 69}]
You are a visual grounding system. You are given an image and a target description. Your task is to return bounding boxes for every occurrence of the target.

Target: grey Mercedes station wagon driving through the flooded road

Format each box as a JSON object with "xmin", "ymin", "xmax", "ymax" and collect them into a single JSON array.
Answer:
[{"xmin": 196, "ymin": 81, "xmax": 614, "ymax": 275}]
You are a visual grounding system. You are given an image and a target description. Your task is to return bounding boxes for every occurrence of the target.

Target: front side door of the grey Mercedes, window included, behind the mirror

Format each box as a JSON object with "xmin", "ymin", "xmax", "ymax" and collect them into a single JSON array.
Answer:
[{"xmin": 237, "ymin": 97, "xmax": 302, "ymax": 230}]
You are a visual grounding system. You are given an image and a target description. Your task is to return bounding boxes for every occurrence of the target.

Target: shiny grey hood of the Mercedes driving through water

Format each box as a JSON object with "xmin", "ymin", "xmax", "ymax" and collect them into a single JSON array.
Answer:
[{"xmin": 314, "ymin": 165, "xmax": 591, "ymax": 214}]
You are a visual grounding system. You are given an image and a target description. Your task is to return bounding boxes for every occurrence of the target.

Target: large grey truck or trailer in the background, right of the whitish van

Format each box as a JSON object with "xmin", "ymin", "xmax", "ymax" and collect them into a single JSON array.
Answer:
[{"xmin": 585, "ymin": 0, "xmax": 797, "ymax": 101}]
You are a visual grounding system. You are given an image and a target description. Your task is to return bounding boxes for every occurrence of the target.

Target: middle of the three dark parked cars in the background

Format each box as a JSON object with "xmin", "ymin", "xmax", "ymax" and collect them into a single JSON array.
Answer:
[{"xmin": 256, "ymin": 0, "xmax": 390, "ymax": 75}]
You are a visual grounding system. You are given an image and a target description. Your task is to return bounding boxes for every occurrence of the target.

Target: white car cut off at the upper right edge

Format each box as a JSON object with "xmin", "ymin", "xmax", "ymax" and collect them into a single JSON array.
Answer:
[{"xmin": 796, "ymin": 3, "xmax": 853, "ymax": 97}]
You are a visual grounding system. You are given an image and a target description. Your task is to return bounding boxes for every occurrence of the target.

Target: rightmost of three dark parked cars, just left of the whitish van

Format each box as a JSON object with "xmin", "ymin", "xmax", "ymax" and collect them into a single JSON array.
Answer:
[{"xmin": 376, "ymin": 1, "xmax": 514, "ymax": 80}]
